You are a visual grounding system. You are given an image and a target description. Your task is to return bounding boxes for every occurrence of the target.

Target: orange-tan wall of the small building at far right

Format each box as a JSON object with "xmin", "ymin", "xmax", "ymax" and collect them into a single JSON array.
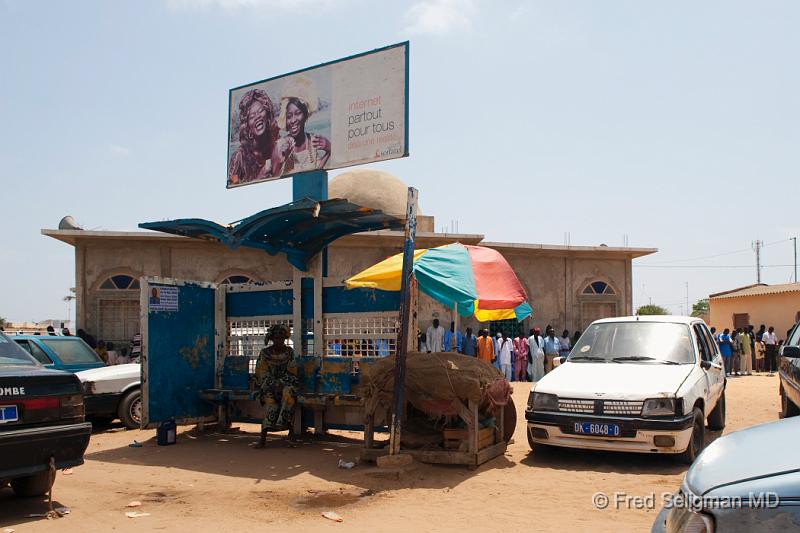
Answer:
[{"xmin": 709, "ymin": 292, "xmax": 800, "ymax": 339}]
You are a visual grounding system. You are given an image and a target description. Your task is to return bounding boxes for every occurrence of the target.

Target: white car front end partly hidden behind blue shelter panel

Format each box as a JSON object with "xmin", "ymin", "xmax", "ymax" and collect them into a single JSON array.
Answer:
[{"xmin": 75, "ymin": 363, "xmax": 142, "ymax": 429}]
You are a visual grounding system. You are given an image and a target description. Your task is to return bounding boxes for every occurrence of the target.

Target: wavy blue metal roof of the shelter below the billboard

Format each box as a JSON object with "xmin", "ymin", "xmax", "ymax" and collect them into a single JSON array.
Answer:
[{"xmin": 139, "ymin": 198, "xmax": 404, "ymax": 271}]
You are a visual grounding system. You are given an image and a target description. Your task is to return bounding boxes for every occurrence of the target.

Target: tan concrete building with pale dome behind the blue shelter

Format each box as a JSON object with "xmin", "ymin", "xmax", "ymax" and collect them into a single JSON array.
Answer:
[{"xmin": 42, "ymin": 168, "xmax": 656, "ymax": 343}]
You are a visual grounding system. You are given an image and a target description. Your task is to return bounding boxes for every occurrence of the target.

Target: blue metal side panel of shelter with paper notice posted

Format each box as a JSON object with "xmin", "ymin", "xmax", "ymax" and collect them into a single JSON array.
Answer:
[{"xmin": 141, "ymin": 278, "xmax": 224, "ymax": 428}]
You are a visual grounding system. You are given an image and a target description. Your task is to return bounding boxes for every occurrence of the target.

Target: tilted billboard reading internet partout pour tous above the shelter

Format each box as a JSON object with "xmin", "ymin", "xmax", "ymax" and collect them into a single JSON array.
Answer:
[{"xmin": 227, "ymin": 42, "xmax": 408, "ymax": 188}]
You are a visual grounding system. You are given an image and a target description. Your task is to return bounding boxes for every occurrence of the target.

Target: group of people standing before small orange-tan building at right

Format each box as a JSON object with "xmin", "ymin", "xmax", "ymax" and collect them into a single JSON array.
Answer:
[{"xmin": 711, "ymin": 324, "xmax": 791, "ymax": 376}]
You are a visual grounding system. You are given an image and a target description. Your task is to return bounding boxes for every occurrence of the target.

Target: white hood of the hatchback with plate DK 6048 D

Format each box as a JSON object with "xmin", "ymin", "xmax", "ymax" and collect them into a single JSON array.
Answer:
[{"xmin": 534, "ymin": 362, "xmax": 694, "ymax": 400}]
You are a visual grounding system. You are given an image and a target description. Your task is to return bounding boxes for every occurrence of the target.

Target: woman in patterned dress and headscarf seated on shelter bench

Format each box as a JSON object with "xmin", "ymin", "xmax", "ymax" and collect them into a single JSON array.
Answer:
[{"xmin": 255, "ymin": 324, "xmax": 298, "ymax": 448}]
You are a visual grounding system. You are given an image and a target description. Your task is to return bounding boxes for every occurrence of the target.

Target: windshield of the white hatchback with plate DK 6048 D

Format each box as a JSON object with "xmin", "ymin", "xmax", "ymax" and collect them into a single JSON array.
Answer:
[{"xmin": 568, "ymin": 322, "xmax": 695, "ymax": 364}]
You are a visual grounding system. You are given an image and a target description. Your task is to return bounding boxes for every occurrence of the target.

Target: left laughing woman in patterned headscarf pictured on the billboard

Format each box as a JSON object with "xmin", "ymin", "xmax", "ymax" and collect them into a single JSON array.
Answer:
[{"xmin": 228, "ymin": 89, "xmax": 278, "ymax": 185}]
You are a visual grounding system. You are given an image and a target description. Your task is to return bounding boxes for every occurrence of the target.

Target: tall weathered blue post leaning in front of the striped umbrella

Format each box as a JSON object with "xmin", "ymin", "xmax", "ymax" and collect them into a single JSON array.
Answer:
[{"xmin": 389, "ymin": 187, "xmax": 419, "ymax": 455}]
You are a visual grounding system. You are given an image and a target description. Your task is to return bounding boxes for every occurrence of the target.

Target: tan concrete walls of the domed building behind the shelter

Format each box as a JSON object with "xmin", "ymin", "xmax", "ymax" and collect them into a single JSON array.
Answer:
[{"xmin": 75, "ymin": 235, "xmax": 632, "ymax": 342}]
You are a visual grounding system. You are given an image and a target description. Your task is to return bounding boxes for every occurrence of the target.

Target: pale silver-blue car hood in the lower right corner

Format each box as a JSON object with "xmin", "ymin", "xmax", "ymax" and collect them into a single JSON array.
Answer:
[{"xmin": 684, "ymin": 417, "xmax": 800, "ymax": 498}]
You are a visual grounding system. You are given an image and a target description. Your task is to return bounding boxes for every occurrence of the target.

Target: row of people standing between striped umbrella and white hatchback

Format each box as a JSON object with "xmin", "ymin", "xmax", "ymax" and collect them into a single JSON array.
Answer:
[{"xmin": 418, "ymin": 318, "xmax": 581, "ymax": 381}]
